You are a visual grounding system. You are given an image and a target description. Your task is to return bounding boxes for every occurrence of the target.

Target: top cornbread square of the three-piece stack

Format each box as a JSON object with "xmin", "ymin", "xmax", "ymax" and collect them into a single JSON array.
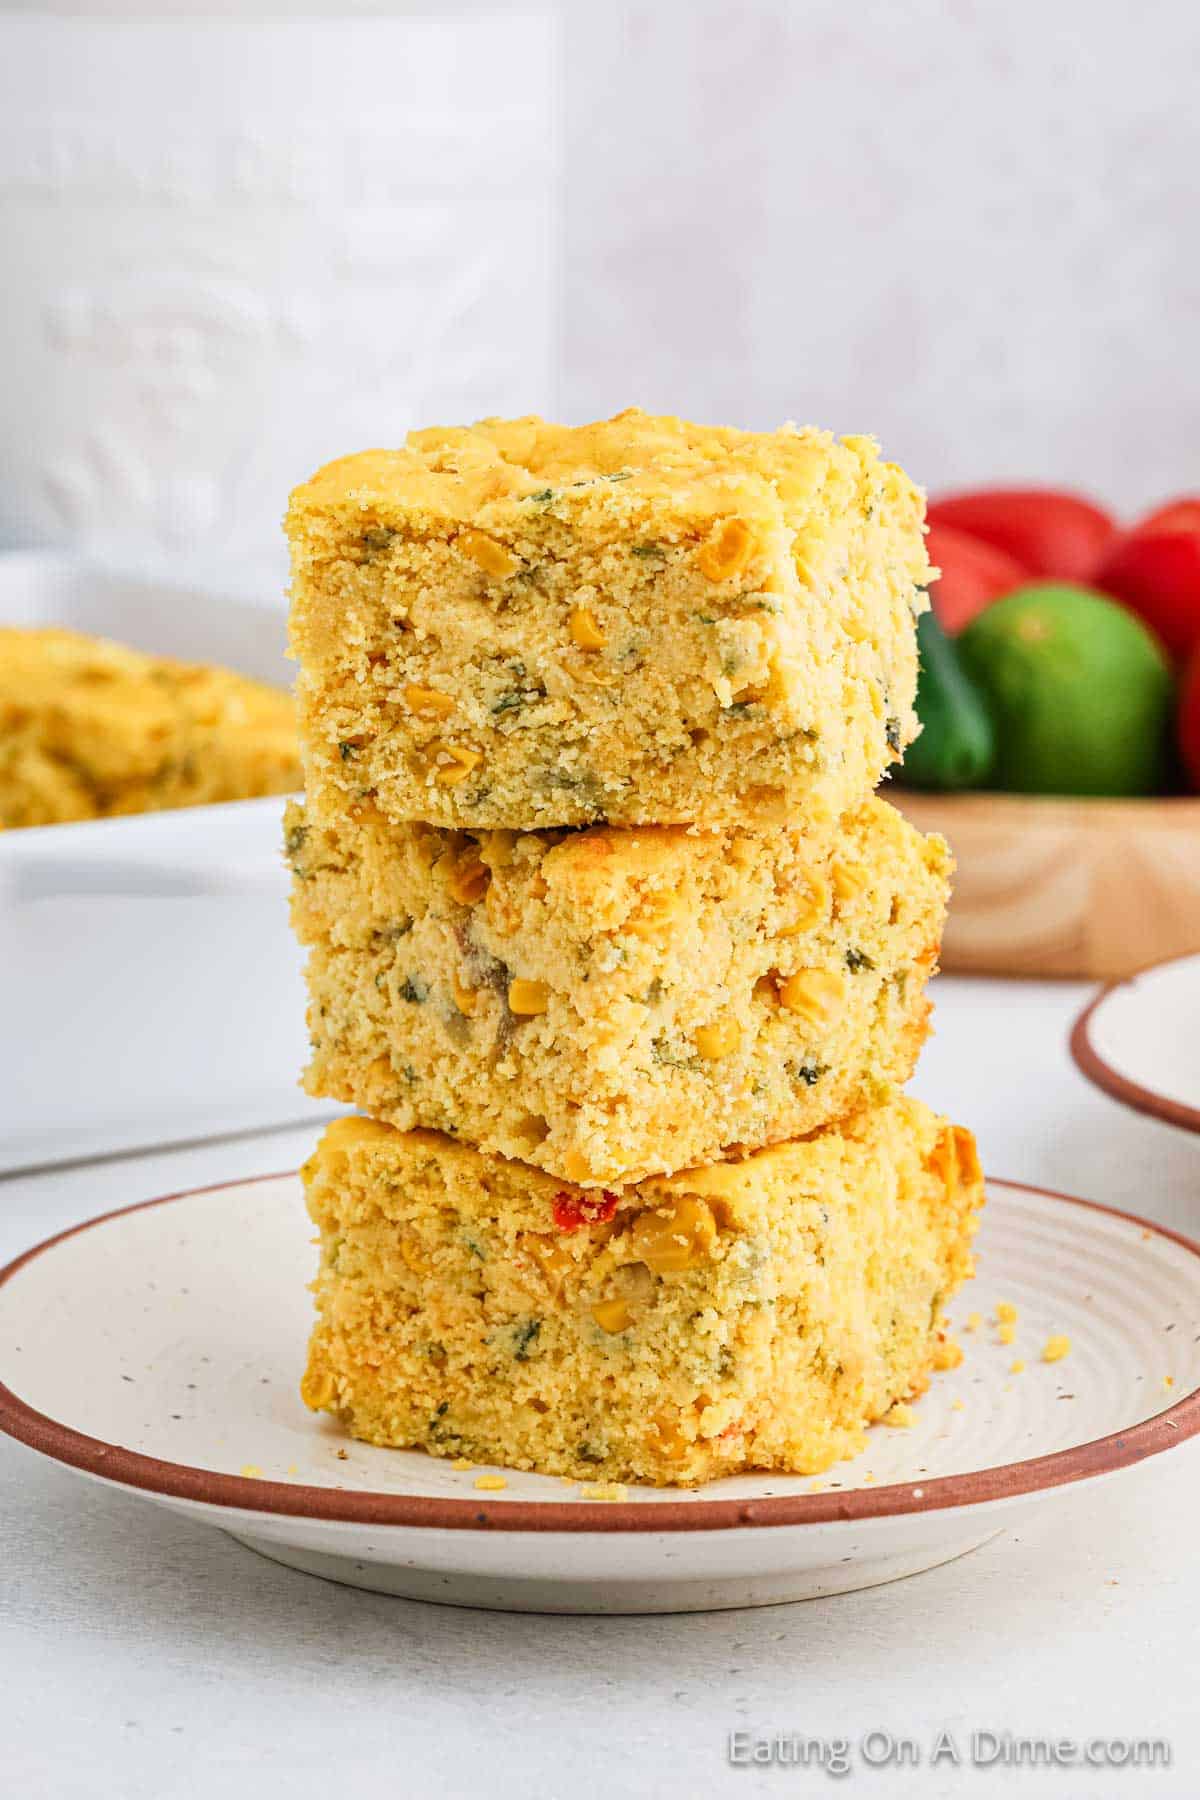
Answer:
[{"xmin": 288, "ymin": 410, "xmax": 928, "ymax": 828}]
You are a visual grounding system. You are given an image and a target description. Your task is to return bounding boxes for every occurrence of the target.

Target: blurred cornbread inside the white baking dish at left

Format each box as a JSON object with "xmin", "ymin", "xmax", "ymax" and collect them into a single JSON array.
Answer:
[{"xmin": 0, "ymin": 626, "xmax": 300, "ymax": 828}]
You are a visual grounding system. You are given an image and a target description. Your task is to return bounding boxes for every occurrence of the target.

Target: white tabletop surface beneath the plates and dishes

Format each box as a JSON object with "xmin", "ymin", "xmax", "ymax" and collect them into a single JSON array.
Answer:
[{"xmin": 0, "ymin": 977, "xmax": 1200, "ymax": 1800}]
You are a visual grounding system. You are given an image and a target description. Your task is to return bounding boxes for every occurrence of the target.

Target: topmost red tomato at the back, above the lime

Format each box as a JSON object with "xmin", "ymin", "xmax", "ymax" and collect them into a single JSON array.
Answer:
[{"xmin": 928, "ymin": 488, "xmax": 1117, "ymax": 581}]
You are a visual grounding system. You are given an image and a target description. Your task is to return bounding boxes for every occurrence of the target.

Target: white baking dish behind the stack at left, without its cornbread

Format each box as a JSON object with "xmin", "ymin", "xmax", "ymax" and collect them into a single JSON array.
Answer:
[{"xmin": 0, "ymin": 554, "xmax": 333, "ymax": 1172}]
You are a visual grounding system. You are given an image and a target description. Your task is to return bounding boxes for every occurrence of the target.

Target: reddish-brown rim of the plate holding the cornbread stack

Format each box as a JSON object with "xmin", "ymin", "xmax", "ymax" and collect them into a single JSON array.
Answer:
[{"xmin": 0, "ymin": 1170, "xmax": 1200, "ymax": 1532}]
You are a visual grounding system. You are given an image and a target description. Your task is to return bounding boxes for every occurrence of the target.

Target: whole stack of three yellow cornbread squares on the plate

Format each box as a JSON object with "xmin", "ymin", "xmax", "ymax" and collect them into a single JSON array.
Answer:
[{"xmin": 286, "ymin": 412, "xmax": 982, "ymax": 1485}]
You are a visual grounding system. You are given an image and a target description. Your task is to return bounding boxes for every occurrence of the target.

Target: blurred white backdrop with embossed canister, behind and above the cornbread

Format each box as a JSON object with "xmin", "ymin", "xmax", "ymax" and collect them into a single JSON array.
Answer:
[{"xmin": 0, "ymin": 0, "xmax": 1200, "ymax": 578}]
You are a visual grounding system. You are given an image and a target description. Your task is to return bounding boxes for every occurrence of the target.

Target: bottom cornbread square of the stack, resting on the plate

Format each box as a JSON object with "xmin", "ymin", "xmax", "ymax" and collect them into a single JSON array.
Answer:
[{"xmin": 302, "ymin": 1093, "xmax": 982, "ymax": 1485}]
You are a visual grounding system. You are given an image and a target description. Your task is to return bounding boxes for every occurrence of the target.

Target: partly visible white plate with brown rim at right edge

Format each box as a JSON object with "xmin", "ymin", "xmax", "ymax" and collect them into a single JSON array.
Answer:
[{"xmin": 1070, "ymin": 956, "xmax": 1200, "ymax": 1132}]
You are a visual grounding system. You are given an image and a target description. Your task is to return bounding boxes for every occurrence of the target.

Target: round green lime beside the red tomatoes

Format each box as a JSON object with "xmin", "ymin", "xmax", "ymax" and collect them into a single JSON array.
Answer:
[{"xmin": 957, "ymin": 581, "xmax": 1173, "ymax": 794}]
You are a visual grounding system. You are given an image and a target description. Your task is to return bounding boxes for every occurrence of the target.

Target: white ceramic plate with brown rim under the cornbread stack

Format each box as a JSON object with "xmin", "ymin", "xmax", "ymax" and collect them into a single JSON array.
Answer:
[{"xmin": 0, "ymin": 1175, "xmax": 1200, "ymax": 1613}]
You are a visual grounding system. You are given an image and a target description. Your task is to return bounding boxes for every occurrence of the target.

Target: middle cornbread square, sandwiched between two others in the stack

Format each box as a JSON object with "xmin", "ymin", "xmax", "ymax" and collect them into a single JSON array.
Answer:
[{"xmin": 286, "ymin": 799, "xmax": 950, "ymax": 1186}]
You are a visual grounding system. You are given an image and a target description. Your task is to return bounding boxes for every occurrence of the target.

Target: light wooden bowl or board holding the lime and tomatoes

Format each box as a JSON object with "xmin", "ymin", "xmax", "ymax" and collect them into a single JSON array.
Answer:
[{"xmin": 885, "ymin": 787, "xmax": 1200, "ymax": 979}]
